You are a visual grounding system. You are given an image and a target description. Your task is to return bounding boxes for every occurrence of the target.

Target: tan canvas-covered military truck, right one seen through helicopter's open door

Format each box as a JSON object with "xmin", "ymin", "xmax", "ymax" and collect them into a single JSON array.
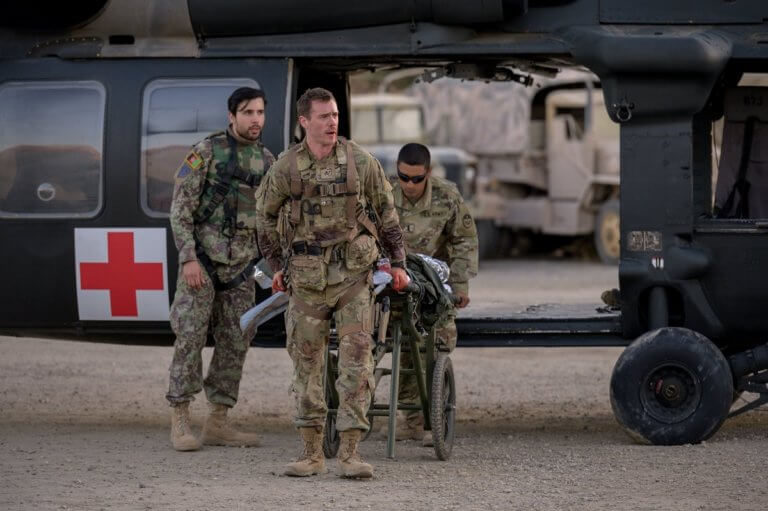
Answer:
[{"xmin": 410, "ymin": 71, "xmax": 620, "ymax": 264}]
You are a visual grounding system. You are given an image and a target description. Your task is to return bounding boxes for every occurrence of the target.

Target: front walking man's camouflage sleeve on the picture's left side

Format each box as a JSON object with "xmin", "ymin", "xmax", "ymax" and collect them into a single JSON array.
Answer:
[{"xmin": 256, "ymin": 159, "xmax": 291, "ymax": 271}]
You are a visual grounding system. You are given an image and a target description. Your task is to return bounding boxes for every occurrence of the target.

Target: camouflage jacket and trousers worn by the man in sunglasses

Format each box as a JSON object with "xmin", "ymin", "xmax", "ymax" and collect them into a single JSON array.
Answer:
[{"xmin": 393, "ymin": 176, "xmax": 477, "ymax": 424}]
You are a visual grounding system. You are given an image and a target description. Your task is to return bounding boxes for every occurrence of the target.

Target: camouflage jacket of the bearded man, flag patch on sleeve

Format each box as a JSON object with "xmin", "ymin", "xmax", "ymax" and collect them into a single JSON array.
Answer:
[{"xmin": 170, "ymin": 132, "xmax": 274, "ymax": 266}]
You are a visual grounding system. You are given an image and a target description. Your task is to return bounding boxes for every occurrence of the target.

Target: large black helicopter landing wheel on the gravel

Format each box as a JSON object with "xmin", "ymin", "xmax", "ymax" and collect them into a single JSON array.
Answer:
[{"xmin": 611, "ymin": 328, "xmax": 733, "ymax": 445}]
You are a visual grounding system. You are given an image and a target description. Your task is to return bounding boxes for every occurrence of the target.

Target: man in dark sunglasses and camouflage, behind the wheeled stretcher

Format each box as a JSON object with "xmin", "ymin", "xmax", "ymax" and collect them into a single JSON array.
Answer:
[{"xmin": 394, "ymin": 144, "xmax": 478, "ymax": 446}]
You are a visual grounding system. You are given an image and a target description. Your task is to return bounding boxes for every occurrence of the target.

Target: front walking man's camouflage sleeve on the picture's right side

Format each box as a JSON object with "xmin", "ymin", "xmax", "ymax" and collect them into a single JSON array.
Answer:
[{"xmin": 364, "ymin": 156, "xmax": 405, "ymax": 263}]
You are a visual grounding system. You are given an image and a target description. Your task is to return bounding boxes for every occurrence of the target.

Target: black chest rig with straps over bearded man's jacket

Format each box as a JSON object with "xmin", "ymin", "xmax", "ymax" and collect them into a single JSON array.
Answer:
[{"xmin": 193, "ymin": 133, "xmax": 264, "ymax": 238}]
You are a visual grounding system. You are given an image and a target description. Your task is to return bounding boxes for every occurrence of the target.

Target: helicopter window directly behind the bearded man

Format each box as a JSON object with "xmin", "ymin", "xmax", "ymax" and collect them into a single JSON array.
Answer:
[{"xmin": 141, "ymin": 78, "xmax": 260, "ymax": 217}]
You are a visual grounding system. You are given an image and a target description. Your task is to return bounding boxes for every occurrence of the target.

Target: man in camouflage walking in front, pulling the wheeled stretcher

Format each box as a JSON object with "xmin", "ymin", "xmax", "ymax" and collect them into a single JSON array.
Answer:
[{"xmin": 257, "ymin": 88, "xmax": 407, "ymax": 477}]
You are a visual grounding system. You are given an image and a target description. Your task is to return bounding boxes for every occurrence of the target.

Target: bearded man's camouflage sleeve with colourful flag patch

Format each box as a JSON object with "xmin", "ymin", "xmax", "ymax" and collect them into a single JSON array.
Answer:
[{"xmin": 170, "ymin": 143, "xmax": 211, "ymax": 265}]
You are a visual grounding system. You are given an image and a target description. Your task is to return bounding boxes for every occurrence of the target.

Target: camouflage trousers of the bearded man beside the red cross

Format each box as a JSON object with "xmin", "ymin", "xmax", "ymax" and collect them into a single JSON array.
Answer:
[{"xmin": 166, "ymin": 263, "xmax": 255, "ymax": 407}]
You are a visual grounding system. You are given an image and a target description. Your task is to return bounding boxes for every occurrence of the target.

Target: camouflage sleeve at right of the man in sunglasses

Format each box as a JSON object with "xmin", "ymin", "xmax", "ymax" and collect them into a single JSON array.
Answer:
[{"xmin": 446, "ymin": 198, "xmax": 478, "ymax": 294}]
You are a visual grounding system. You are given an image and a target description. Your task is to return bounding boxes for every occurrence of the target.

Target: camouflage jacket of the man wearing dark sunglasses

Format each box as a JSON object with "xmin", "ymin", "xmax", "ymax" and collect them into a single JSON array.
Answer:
[{"xmin": 393, "ymin": 176, "xmax": 477, "ymax": 294}]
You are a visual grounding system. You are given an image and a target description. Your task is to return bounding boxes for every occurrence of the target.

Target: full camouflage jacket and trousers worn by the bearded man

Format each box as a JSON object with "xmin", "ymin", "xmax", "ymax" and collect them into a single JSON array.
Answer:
[{"xmin": 166, "ymin": 130, "xmax": 274, "ymax": 407}]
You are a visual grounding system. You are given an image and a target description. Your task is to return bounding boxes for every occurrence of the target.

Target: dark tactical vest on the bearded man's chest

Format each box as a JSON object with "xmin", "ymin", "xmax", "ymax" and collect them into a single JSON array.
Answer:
[{"xmin": 194, "ymin": 133, "xmax": 265, "ymax": 238}]
